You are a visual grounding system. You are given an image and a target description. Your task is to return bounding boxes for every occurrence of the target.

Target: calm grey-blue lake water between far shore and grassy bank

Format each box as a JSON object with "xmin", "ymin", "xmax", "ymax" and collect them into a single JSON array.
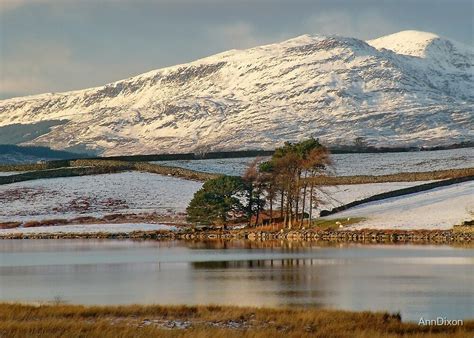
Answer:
[{"xmin": 0, "ymin": 240, "xmax": 474, "ymax": 321}]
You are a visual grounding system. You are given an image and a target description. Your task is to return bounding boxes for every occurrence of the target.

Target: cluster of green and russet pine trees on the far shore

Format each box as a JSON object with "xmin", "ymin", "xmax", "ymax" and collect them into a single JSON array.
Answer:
[{"xmin": 187, "ymin": 138, "xmax": 331, "ymax": 228}]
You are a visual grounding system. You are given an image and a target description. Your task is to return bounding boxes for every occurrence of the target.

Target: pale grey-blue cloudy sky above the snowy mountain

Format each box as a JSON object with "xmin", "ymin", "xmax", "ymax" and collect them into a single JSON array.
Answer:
[{"xmin": 0, "ymin": 0, "xmax": 474, "ymax": 99}]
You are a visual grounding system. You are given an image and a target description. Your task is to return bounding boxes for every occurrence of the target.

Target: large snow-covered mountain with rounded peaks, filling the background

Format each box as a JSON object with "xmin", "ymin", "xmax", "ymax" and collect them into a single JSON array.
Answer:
[{"xmin": 0, "ymin": 31, "xmax": 474, "ymax": 155}]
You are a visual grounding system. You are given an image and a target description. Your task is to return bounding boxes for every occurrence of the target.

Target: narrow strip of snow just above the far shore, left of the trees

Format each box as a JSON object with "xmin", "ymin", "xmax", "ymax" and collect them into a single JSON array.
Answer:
[{"xmin": 0, "ymin": 223, "xmax": 176, "ymax": 236}]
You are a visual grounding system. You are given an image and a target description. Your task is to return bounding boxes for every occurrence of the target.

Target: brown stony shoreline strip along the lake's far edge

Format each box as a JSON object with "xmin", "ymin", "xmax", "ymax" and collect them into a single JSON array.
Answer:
[{"xmin": 0, "ymin": 229, "xmax": 473, "ymax": 245}]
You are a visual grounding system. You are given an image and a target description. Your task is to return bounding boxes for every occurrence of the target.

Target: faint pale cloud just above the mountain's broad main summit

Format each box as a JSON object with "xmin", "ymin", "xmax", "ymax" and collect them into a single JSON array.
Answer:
[{"xmin": 304, "ymin": 10, "xmax": 399, "ymax": 40}]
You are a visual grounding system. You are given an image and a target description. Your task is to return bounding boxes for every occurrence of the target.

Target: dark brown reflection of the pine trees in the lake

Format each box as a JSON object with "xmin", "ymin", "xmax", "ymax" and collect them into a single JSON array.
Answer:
[{"xmin": 191, "ymin": 259, "xmax": 330, "ymax": 307}]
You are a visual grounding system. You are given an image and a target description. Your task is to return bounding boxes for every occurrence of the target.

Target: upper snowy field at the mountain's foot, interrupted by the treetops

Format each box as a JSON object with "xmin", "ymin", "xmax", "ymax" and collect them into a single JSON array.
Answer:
[{"xmin": 153, "ymin": 148, "xmax": 474, "ymax": 176}]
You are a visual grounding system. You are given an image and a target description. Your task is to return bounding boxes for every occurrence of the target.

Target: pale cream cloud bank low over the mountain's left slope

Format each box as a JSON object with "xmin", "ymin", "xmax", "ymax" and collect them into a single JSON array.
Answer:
[{"xmin": 0, "ymin": 40, "xmax": 167, "ymax": 99}]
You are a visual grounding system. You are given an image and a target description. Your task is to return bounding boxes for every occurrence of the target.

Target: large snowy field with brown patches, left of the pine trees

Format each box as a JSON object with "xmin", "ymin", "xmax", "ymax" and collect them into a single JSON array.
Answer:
[{"xmin": 0, "ymin": 172, "xmax": 201, "ymax": 222}]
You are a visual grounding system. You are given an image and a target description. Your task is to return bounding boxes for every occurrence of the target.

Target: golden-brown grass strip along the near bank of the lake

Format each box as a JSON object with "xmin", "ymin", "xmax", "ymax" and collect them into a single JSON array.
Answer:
[{"xmin": 0, "ymin": 304, "xmax": 474, "ymax": 338}]
